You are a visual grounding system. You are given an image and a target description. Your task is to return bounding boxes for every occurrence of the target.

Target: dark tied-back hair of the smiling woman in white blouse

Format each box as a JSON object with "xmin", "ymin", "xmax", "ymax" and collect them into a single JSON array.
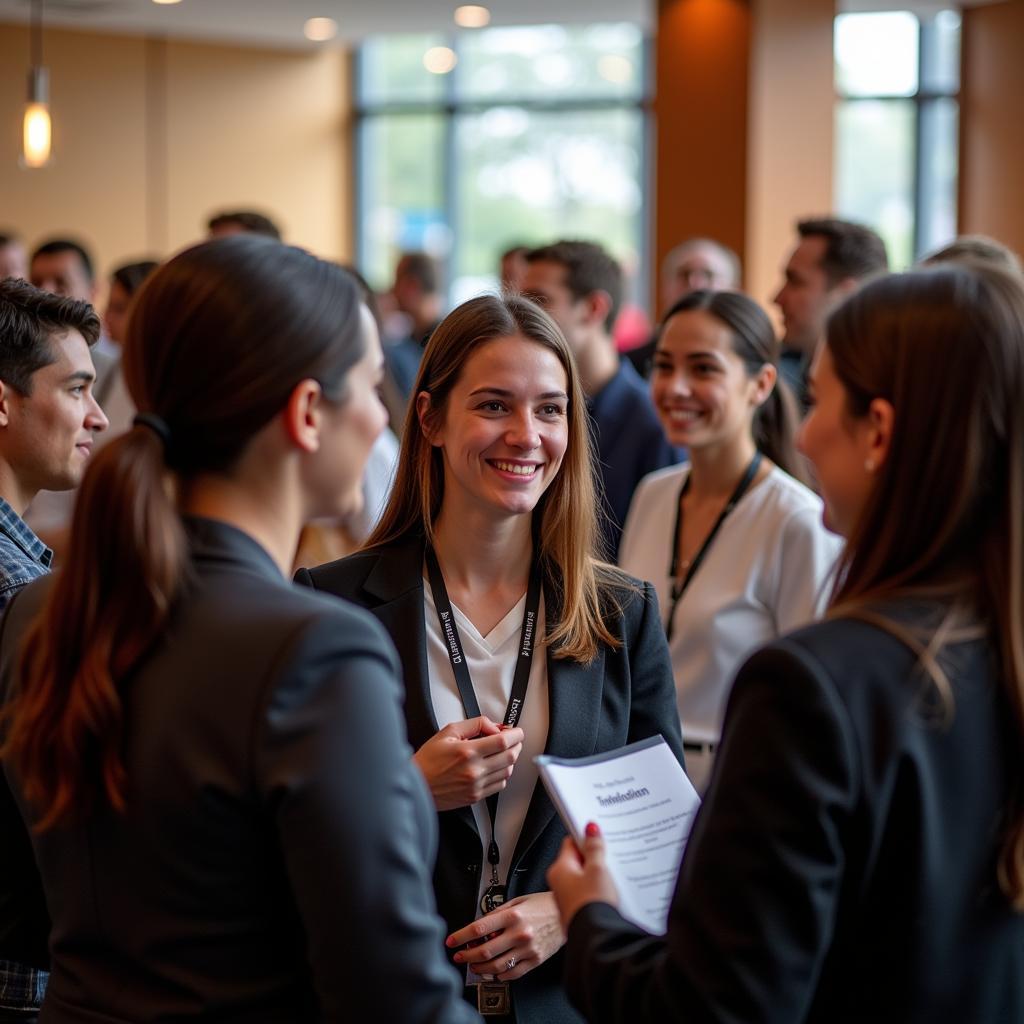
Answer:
[{"xmin": 660, "ymin": 290, "xmax": 809, "ymax": 483}]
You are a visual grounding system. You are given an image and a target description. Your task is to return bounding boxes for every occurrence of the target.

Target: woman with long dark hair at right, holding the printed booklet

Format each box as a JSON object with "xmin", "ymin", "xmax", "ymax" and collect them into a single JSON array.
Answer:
[{"xmin": 549, "ymin": 264, "xmax": 1024, "ymax": 1024}]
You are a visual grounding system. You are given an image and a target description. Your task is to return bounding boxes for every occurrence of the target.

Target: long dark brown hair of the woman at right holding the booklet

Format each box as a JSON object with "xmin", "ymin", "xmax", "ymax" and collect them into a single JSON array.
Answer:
[{"xmin": 826, "ymin": 260, "xmax": 1024, "ymax": 912}]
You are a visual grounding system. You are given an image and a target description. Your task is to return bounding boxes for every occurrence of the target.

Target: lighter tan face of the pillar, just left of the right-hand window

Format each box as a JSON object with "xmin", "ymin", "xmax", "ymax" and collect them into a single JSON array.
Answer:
[{"xmin": 744, "ymin": 0, "xmax": 836, "ymax": 315}]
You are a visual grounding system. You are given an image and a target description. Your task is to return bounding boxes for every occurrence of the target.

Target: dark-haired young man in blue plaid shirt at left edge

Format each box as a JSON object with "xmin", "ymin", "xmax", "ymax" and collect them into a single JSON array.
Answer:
[{"xmin": 0, "ymin": 279, "xmax": 106, "ymax": 1024}]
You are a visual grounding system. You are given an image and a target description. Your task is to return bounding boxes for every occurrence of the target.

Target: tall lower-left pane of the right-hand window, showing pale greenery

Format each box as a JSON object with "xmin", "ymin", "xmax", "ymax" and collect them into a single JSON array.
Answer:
[{"xmin": 834, "ymin": 99, "xmax": 915, "ymax": 269}]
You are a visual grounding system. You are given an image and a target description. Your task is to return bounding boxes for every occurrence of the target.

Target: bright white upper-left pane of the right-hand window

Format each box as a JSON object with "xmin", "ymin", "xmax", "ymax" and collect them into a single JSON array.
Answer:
[{"xmin": 835, "ymin": 10, "xmax": 919, "ymax": 96}]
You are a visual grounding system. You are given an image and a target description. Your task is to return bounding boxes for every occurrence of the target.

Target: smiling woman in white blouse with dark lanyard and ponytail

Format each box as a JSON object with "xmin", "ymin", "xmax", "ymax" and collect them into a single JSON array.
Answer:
[{"xmin": 620, "ymin": 291, "xmax": 842, "ymax": 792}]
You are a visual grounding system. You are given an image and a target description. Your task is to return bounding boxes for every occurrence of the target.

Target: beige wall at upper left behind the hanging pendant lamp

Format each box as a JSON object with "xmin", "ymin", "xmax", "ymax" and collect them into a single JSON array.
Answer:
[{"xmin": 0, "ymin": 26, "xmax": 351, "ymax": 288}]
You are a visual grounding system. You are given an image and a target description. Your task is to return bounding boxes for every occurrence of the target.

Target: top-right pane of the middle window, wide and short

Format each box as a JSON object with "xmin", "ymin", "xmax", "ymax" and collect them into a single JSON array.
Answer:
[{"xmin": 458, "ymin": 24, "xmax": 643, "ymax": 102}]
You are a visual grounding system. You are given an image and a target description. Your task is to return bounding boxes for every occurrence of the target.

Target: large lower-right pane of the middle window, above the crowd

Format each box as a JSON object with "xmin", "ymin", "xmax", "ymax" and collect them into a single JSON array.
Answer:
[{"xmin": 453, "ymin": 108, "xmax": 643, "ymax": 301}]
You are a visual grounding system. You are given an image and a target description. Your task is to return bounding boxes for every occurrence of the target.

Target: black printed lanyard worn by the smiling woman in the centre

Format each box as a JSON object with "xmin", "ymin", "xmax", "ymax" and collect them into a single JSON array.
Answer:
[{"xmin": 424, "ymin": 546, "xmax": 541, "ymax": 913}]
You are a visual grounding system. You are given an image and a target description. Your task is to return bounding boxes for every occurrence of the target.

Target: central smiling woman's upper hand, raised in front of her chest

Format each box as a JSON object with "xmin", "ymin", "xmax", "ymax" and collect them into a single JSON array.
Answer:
[{"xmin": 413, "ymin": 715, "xmax": 523, "ymax": 811}]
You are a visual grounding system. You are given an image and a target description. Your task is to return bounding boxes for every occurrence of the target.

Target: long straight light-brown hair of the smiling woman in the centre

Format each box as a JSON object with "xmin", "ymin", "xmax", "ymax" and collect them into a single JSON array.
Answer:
[{"xmin": 364, "ymin": 295, "xmax": 632, "ymax": 664}]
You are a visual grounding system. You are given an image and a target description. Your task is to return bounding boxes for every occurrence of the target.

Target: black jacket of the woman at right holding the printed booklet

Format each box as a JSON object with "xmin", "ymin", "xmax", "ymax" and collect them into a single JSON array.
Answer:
[{"xmin": 567, "ymin": 609, "xmax": 1024, "ymax": 1024}]
